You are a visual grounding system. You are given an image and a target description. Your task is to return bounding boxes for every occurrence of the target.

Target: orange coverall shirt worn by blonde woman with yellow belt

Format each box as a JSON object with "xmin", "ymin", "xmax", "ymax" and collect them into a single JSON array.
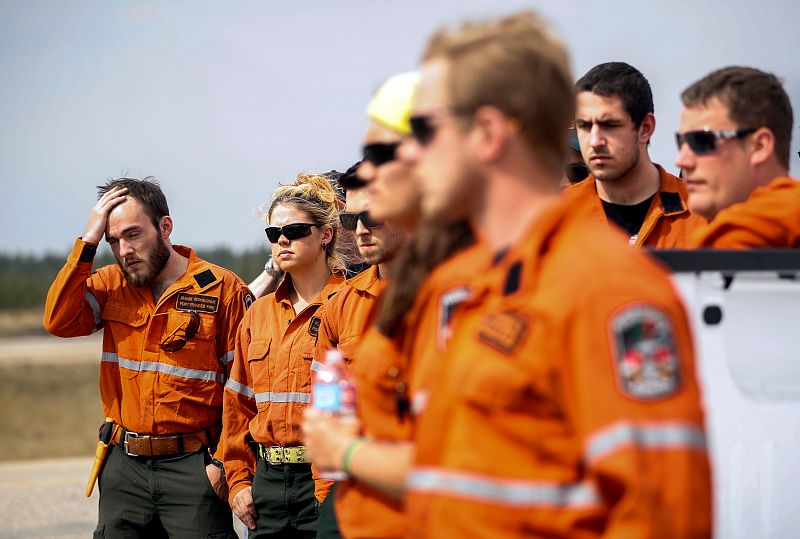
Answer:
[{"xmin": 222, "ymin": 275, "xmax": 344, "ymax": 501}]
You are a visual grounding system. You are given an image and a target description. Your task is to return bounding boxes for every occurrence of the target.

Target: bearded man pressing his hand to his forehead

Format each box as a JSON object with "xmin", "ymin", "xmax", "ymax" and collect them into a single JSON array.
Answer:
[{"xmin": 44, "ymin": 178, "xmax": 253, "ymax": 538}]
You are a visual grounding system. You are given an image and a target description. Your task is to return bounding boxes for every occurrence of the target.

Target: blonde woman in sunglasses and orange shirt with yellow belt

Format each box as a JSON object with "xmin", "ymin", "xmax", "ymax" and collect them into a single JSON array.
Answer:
[{"xmin": 223, "ymin": 175, "xmax": 347, "ymax": 538}]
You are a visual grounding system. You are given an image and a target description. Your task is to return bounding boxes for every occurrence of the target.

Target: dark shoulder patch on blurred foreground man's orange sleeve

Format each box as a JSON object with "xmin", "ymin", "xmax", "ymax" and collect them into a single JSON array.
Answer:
[{"xmin": 611, "ymin": 306, "xmax": 681, "ymax": 400}]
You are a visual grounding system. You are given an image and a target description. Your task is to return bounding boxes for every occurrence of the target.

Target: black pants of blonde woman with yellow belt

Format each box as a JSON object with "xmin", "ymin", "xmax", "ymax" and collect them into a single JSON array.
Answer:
[{"xmin": 249, "ymin": 459, "xmax": 319, "ymax": 539}]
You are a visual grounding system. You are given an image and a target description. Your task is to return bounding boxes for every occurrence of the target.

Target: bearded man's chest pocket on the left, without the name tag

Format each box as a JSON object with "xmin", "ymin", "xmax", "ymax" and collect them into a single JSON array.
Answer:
[{"xmin": 101, "ymin": 301, "xmax": 150, "ymax": 378}]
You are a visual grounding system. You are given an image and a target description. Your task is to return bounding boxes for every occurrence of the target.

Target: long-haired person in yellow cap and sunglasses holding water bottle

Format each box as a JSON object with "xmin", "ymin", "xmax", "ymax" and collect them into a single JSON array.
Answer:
[{"xmin": 303, "ymin": 74, "xmax": 486, "ymax": 539}]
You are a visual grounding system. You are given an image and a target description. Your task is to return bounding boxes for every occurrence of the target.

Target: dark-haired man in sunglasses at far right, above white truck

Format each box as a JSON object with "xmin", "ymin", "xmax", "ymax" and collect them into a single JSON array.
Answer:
[{"xmin": 676, "ymin": 67, "xmax": 800, "ymax": 249}]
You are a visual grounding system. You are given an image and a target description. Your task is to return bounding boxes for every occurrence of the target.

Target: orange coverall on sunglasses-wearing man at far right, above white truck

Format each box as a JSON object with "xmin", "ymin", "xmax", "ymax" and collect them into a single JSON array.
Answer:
[{"xmin": 692, "ymin": 177, "xmax": 800, "ymax": 249}]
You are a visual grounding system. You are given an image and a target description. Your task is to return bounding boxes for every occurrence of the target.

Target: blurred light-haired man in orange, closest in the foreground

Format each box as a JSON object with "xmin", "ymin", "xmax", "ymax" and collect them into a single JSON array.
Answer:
[{"xmin": 399, "ymin": 13, "xmax": 711, "ymax": 538}]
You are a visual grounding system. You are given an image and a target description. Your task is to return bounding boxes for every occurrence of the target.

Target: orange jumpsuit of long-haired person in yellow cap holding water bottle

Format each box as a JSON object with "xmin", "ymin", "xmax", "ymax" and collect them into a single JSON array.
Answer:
[{"xmin": 335, "ymin": 246, "xmax": 489, "ymax": 539}]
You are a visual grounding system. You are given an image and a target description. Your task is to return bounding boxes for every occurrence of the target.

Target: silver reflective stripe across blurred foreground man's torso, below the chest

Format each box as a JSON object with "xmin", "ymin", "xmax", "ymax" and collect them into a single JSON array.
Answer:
[{"xmin": 408, "ymin": 468, "xmax": 600, "ymax": 509}]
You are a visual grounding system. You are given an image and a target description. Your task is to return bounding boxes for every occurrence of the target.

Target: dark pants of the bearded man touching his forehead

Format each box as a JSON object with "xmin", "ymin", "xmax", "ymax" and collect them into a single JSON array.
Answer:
[{"xmin": 94, "ymin": 445, "xmax": 236, "ymax": 539}]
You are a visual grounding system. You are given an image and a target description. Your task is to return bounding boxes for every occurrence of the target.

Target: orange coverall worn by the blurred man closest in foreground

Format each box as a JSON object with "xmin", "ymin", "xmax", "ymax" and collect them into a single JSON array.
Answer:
[{"xmin": 406, "ymin": 197, "xmax": 711, "ymax": 539}]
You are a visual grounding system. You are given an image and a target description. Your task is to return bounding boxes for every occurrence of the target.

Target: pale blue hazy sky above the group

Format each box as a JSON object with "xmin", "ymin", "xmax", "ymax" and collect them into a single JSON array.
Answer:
[{"xmin": 0, "ymin": 0, "xmax": 800, "ymax": 253}]
